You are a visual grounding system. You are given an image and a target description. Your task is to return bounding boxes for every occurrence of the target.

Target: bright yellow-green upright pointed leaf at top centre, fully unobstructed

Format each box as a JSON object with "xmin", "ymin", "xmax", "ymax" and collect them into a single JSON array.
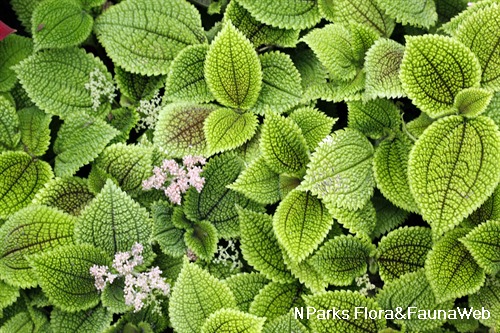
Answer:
[{"xmin": 205, "ymin": 22, "xmax": 262, "ymax": 109}]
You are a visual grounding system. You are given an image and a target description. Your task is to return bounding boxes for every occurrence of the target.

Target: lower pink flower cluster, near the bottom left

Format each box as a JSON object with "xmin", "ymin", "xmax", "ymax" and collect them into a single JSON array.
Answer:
[{"xmin": 90, "ymin": 243, "xmax": 170, "ymax": 312}]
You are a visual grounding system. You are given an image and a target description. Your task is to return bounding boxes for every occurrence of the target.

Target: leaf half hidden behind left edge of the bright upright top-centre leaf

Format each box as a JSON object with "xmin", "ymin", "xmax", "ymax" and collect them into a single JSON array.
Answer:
[{"xmin": 165, "ymin": 44, "xmax": 214, "ymax": 103}]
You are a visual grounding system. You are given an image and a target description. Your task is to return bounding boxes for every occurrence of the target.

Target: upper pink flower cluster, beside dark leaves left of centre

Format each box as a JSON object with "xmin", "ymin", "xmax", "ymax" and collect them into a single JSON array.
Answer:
[{"xmin": 142, "ymin": 155, "xmax": 206, "ymax": 205}]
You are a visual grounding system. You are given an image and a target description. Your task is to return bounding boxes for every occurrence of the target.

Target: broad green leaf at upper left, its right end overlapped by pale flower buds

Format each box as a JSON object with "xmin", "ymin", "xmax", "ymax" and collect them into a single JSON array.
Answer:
[{"xmin": 14, "ymin": 47, "xmax": 112, "ymax": 118}]
